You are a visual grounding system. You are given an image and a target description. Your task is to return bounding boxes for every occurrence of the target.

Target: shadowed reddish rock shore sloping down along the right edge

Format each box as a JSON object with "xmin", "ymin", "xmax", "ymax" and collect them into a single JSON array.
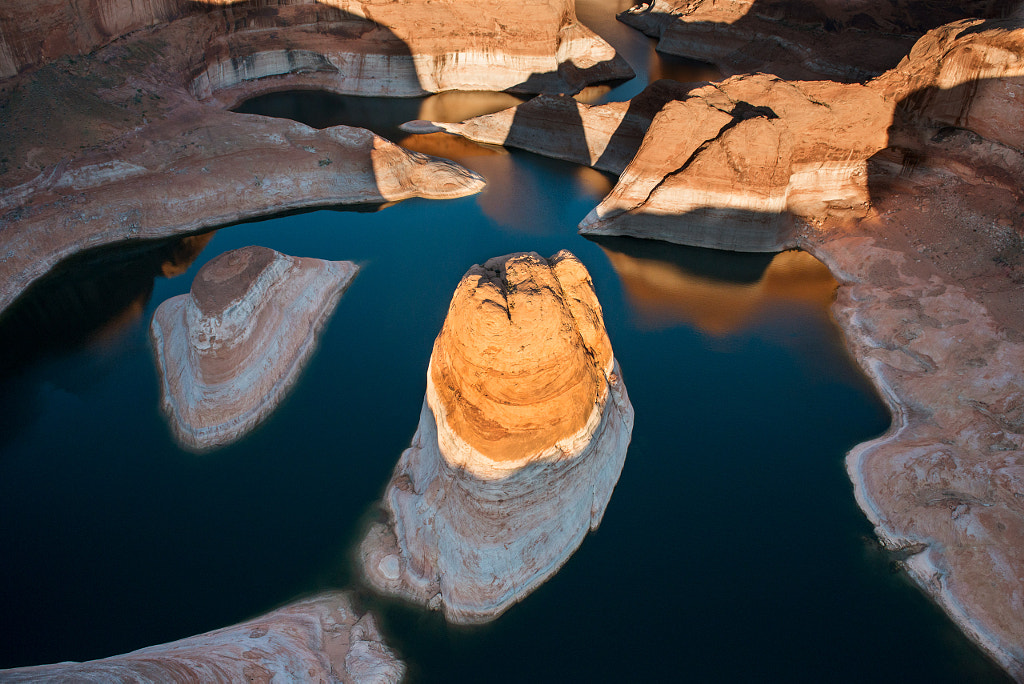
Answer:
[{"xmin": 801, "ymin": 143, "xmax": 1024, "ymax": 681}]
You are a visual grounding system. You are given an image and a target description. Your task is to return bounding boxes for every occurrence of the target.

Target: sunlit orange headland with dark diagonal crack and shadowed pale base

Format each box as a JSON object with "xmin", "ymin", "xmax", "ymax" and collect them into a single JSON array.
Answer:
[{"xmin": 580, "ymin": 74, "xmax": 893, "ymax": 252}]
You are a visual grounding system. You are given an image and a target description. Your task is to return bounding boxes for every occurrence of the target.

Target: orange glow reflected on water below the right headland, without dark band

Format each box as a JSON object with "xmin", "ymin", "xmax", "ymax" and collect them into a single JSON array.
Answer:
[{"xmin": 601, "ymin": 246, "xmax": 839, "ymax": 337}]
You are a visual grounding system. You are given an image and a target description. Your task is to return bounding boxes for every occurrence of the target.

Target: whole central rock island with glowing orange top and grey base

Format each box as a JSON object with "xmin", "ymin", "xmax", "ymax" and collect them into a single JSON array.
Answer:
[{"xmin": 360, "ymin": 251, "xmax": 633, "ymax": 624}]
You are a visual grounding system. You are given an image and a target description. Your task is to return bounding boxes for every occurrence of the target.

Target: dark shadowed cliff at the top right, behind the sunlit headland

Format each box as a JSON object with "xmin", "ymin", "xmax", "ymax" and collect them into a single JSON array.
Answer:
[{"xmin": 618, "ymin": 0, "xmax": 1020, "ymax": 82}]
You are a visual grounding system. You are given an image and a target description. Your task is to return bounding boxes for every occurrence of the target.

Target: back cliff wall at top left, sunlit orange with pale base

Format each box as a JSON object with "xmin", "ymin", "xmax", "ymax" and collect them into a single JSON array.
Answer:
[{"xmin": 0, "ymin": 0, "xmax": 633, "ymax": 92}]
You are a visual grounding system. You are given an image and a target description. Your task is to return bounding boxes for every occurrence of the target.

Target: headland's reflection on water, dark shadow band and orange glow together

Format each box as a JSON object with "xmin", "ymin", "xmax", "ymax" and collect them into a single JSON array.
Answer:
[{"xmin": 599, "ymin": 238, "xmax": 839, "ymax": 337}]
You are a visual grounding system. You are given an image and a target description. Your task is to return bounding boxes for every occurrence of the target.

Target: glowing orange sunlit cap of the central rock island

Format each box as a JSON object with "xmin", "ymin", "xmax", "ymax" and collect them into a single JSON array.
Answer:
[{"xmin": 430, "ymin": 249, "xmax": 612, "ymax": 462}]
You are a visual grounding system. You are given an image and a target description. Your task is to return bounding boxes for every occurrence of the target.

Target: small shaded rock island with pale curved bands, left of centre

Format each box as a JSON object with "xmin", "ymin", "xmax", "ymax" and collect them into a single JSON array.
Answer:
[{"xmin": 150, "ymin": 247, "xmax": 357, "ymax": 450}]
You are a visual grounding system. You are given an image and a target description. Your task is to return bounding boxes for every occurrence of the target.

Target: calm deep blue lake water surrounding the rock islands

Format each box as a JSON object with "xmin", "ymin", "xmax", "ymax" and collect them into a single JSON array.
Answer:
[{"xmin": 0, "ymin": 1, "xmax": 1000, "ymax": 682}]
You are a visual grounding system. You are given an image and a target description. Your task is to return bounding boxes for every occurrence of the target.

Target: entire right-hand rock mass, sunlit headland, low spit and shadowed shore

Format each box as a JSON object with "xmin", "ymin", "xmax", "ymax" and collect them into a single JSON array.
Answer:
[{"xmin": 411, "ymin": 16, "xmax": 1024, "ymax": 681}]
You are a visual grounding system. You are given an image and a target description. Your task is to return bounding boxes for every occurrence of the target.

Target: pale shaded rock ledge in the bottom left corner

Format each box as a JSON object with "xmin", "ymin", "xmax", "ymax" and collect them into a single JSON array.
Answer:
[{"xmin": 0, "ymin": 592, "xmax": 406, "ymax": 684}]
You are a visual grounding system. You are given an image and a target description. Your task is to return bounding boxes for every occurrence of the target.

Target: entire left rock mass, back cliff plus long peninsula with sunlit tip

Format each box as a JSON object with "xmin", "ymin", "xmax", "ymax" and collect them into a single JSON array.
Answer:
[{"xmin": 0, "ymin": 0, "xmax": 632, "ymax": 311}]
